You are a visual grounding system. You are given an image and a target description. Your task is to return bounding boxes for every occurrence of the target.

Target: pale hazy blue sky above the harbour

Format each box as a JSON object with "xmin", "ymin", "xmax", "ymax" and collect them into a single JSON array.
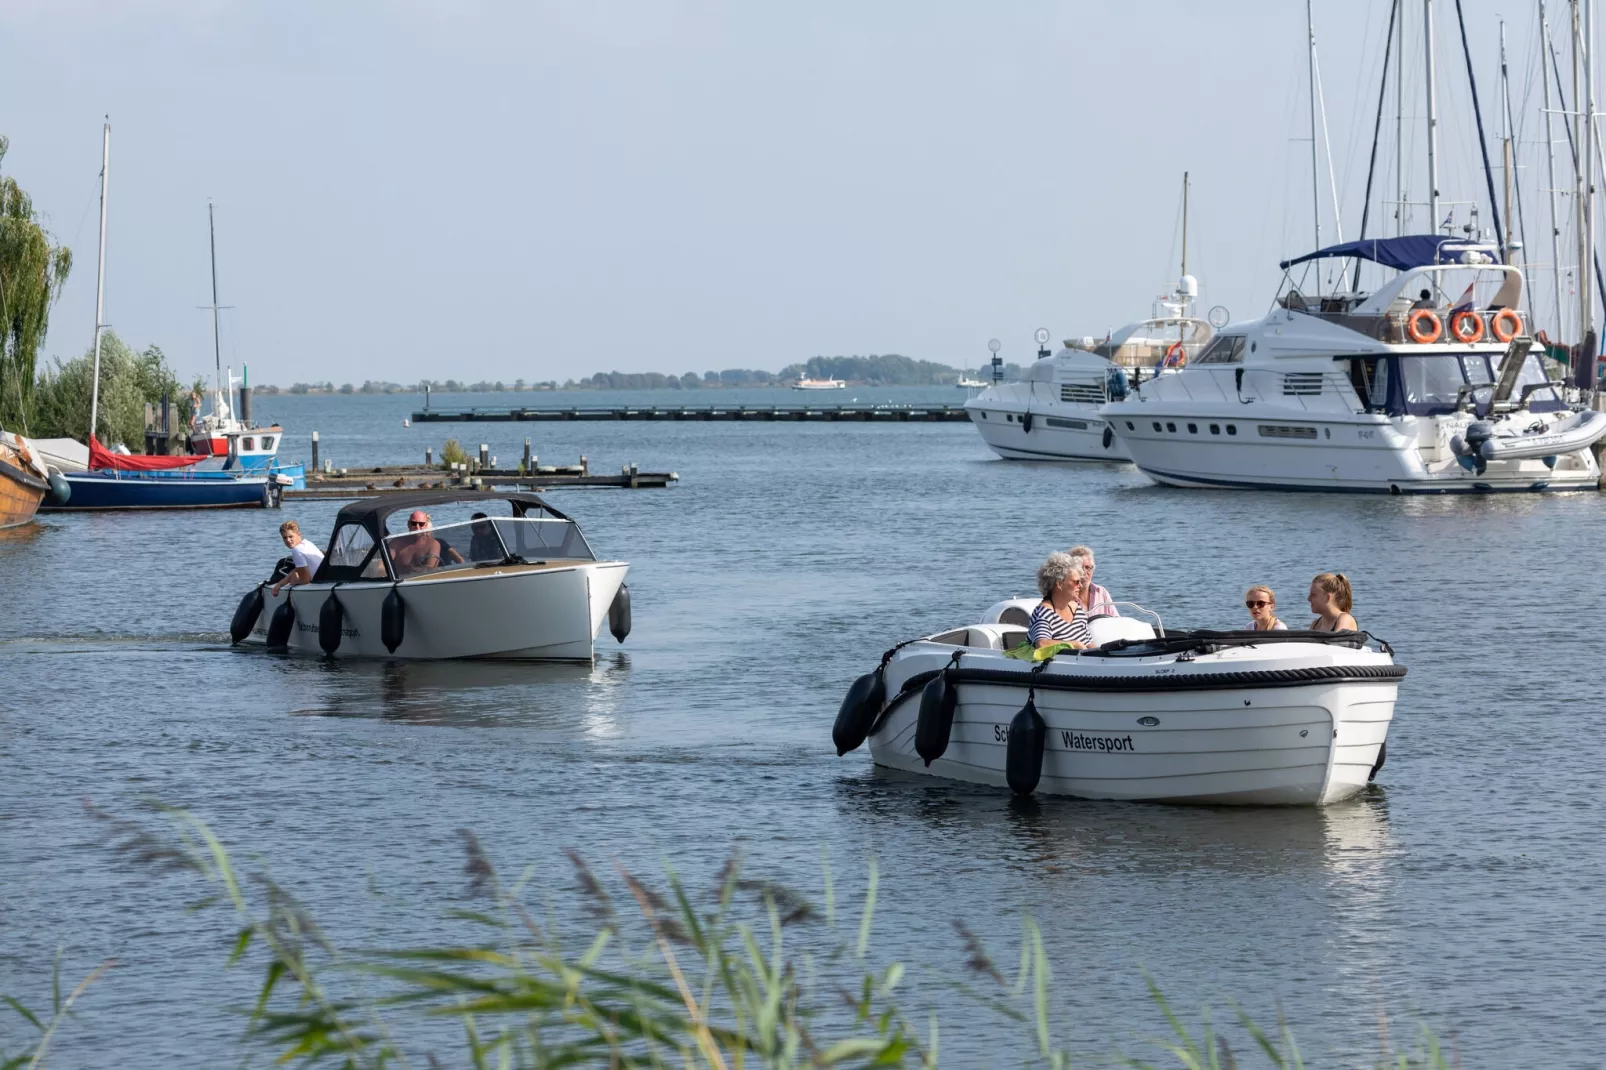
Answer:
[{"xmin": 0, "ymin": 0, "xmax": 1575, "ymax": 386}]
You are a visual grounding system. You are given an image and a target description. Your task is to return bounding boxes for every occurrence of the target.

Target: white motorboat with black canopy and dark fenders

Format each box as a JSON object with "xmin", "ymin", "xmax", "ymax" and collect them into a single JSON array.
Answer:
[{"xmin": 230, "ymin": 490, "xmax": 630, "ymax": 662}]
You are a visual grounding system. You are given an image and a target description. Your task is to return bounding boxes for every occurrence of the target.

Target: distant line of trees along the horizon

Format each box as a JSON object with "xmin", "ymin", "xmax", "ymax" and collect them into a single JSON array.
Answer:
[{"xmin": 255, "ymin": 353, "xmax": 989, "ymax": 394}]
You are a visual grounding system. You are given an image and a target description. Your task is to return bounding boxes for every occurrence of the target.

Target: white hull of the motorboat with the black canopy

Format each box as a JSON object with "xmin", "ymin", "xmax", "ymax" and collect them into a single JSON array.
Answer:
[{"xmin": 246, "ymin": 561, "xmax": 630, "ymax": 662}]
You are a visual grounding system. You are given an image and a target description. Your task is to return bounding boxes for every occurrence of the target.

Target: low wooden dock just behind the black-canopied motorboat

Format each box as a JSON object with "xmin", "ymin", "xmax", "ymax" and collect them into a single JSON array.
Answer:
[{"xmin": 283, "ymin": 458, "xmax": 681, "ymax": 501}]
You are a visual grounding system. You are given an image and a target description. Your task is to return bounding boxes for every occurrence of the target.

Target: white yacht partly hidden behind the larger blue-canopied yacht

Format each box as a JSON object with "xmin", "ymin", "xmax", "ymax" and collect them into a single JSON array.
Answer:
[{"xmin": 965, "ymin": 275, "xmax": 1214, "ymax": 461}]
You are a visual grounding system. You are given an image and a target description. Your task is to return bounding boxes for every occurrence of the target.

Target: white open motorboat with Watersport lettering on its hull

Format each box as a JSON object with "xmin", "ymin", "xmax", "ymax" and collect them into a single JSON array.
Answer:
[{"xmin": 832, "ymin": 599, "xmax": 1405, "ymax": 807}]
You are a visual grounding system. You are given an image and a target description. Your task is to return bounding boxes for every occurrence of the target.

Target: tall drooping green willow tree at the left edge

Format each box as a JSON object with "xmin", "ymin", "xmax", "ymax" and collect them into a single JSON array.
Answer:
[{"xmin": 0, "ymin": 137, "xmax": 72, "ymax": 431}]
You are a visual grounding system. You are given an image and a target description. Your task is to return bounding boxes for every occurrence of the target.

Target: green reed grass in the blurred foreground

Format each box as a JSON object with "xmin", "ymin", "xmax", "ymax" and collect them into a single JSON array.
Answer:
[{"xmin": 0, "ymin": 807, "xmax": 1450, "ymax": 1070}]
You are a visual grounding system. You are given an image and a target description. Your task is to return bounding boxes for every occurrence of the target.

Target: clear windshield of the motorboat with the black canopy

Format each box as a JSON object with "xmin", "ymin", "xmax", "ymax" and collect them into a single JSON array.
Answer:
[{"xmin": 385, "ymin": 516, "xmax": 596, "ymax": 577}]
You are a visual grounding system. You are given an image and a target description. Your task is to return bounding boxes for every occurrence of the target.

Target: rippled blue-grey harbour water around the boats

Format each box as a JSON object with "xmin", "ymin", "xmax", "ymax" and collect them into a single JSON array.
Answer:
[{"xmin": 0, "ymin": 390, "xmax": 1606, "ymax": 1067}]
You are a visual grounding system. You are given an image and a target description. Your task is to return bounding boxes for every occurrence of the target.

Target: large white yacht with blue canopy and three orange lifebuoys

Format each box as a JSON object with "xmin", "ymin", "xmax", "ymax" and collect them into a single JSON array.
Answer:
[{"xmin": 1100, "ymin": 235, "xmax": 1606, "ymax": 493}]
